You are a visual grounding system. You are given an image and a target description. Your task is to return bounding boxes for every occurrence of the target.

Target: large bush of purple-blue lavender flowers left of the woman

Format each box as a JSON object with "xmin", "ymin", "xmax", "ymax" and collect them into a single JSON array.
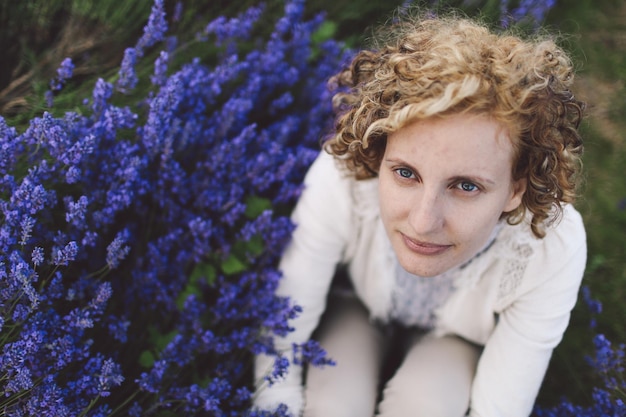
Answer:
[{"xmin": 0, "ymin": 0, "xmax": 343, "ymax": 416}]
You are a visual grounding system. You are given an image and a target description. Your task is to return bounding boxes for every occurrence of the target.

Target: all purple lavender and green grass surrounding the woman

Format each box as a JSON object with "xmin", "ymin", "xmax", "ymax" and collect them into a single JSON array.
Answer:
[{"xmin": 0, "ymin": 0, "xmax": 626, "ymax": 417}]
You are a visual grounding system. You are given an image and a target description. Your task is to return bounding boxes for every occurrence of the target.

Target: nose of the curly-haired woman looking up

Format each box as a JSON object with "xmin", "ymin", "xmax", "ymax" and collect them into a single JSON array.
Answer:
[{"xmin": 408, "ymin": 186, "xmax": 445, "ymax": 237}]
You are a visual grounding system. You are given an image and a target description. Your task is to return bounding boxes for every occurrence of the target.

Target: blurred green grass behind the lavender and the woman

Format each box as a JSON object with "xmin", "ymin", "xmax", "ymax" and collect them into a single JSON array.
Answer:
[{"xmin": 0, "ymin": 0, "xmax": 626, "ymax": 405}]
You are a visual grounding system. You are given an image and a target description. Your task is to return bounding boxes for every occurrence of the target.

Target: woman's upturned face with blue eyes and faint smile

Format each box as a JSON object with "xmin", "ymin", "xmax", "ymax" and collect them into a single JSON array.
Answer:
[{"xmin": 379, "ymin": 114, "xmax": 526, "ymax": 277}]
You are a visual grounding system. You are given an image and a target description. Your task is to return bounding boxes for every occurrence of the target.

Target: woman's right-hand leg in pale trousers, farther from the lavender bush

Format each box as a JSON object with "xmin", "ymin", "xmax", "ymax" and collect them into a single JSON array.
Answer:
[{"xmin": 379, "ymin": 334, "xmax": 481, "ymax": 417}]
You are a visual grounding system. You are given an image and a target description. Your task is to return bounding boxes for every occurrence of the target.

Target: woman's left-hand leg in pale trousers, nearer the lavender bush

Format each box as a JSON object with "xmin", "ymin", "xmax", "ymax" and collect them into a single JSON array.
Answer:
[{"xmin": 304, "ymin": 297, "xmax": 384, "ymax": 417}]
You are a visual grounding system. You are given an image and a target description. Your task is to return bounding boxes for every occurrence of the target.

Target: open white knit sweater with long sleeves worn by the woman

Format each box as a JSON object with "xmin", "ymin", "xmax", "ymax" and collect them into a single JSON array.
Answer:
[{"xmin": 255, "ymin": 153, "xmax": 587, "ymax": 417}]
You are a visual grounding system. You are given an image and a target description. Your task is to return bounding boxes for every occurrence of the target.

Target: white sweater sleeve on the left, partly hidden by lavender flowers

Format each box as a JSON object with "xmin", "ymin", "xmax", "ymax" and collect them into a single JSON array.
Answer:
[{"xmin": 255, "ymin": 152, "xmax": 352, "ymax": 415}]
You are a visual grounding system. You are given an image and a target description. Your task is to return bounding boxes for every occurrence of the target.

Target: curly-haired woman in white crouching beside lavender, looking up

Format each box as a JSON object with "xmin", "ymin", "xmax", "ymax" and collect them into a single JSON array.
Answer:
[{"xmin": 256, "ymin": 10, "xmax": 586, "ymax": 417}]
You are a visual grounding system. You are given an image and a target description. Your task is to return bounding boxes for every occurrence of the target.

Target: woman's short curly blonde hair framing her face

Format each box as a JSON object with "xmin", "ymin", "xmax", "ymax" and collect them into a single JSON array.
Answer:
[{"xmin": 324, "ymin": 12, "xmax": 584, "ymax": 238}]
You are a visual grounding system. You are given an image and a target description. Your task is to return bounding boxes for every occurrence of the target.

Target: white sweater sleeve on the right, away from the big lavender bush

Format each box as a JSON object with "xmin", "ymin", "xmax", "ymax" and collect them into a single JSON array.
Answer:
[{"xmin": 470, "ymin": 207, "xmax": 587, "ymax": 417}]
